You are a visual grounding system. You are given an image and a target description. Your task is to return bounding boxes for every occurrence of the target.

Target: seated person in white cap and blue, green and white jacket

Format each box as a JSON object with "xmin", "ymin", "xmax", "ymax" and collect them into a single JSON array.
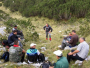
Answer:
[{"xmin": 27, "ymin": 43, "xmax": 40, "ymax": 62}]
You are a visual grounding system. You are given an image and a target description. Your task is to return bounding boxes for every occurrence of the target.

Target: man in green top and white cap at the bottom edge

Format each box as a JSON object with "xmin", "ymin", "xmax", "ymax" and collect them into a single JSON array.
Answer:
[{"xmin": 50, "ymin": 50, "xmax": 69, "ymax": 68}]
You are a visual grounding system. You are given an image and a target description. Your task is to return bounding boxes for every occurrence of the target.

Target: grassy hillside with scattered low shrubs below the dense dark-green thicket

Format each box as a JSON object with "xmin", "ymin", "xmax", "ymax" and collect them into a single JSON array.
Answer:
[{"xmin": 0, "ymin": 0, "xmax": 90, "ymax": 68}]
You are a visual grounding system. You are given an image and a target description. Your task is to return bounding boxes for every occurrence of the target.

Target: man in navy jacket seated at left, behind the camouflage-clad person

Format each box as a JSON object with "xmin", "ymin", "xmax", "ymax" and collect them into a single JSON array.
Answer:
[{"xmin": 8, "ymin": 30, "xmax": 23, "ymax": 47}]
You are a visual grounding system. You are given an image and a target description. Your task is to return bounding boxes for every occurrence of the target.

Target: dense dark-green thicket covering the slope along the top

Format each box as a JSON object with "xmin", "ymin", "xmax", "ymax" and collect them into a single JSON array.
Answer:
[{"xmin": 4, "ymin": 0, "xmax": 90, "ymax": 20}]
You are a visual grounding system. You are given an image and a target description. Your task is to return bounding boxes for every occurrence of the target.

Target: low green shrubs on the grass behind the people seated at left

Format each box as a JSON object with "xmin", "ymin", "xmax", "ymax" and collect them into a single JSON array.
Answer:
[{"xmin": 4, "ymin": 19, "xmax": 39, "ymax": 41}]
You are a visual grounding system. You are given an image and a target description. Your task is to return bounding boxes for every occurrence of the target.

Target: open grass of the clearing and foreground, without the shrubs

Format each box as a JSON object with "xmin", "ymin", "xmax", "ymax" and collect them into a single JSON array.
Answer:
[{"xmin": 0, "ymin": 2, "xmax": 90, "ymax": 68}]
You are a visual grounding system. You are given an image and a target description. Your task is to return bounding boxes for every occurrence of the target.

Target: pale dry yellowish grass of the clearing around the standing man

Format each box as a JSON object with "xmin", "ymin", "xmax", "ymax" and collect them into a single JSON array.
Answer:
[{"xmin": 0, "ymin": 2, "xmax": 90, "ymax": 68}]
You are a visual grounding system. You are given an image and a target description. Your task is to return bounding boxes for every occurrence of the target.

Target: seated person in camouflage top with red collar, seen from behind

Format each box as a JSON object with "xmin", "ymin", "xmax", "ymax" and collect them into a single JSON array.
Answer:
[{"xmin": 9, "ymin": 40, "xmax": 25, "ymax": 62}]
